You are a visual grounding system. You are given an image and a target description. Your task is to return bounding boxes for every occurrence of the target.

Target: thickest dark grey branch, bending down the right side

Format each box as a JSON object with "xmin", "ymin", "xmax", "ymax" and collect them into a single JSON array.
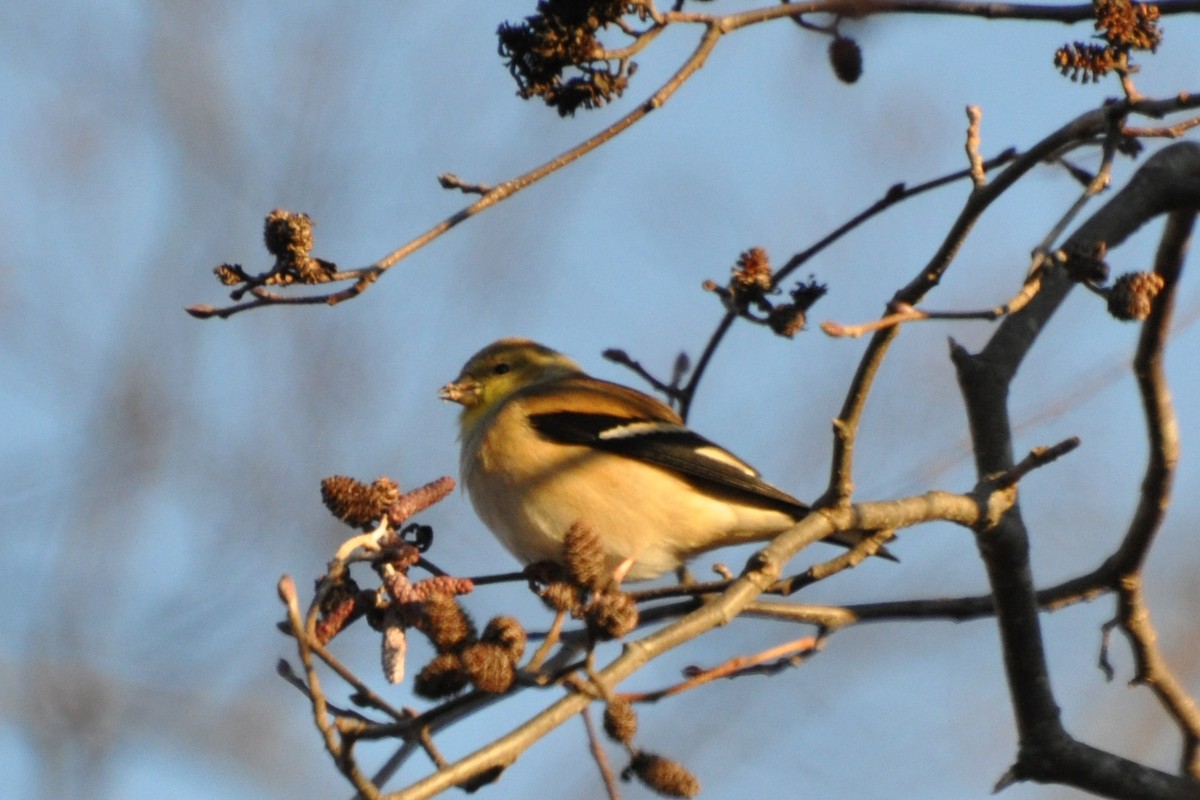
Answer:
[{"xmin": 954, "ymin": 144, "xmax": 1200, "ymax": 798}]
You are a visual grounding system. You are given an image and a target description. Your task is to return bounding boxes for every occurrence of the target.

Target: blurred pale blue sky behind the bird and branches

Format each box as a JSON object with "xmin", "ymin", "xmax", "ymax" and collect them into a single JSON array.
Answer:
[{"xmin": 0, "ymin": 0, "xmax": 1200, "ymax": 800}]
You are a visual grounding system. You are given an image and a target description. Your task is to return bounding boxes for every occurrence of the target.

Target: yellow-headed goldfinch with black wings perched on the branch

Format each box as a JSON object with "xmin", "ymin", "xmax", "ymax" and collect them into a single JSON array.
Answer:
[{"xmin": 439, "ymin": 338, "xmax": 887, "ymax": 581}]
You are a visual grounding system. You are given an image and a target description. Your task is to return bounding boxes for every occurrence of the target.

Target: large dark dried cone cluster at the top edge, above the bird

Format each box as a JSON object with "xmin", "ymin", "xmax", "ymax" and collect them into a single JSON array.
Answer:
[{"xmin": 497, "ymin": 0, "xmax": 646, "ymax": 116}]
